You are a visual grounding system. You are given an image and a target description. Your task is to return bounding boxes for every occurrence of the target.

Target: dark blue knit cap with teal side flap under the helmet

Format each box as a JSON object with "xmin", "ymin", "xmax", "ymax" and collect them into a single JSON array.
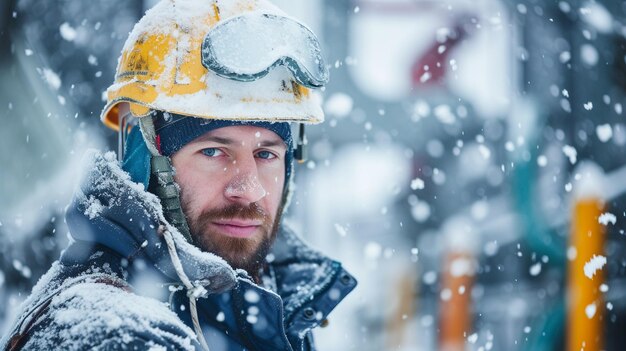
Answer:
[{"xmin": 122, "ymin": 111, "xmax": 293, "ymax": 191}]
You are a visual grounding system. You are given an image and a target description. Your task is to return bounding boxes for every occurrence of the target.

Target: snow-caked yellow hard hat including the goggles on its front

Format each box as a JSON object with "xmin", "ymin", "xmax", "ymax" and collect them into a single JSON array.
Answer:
[{"xmin": 101, "ymin": 0, "xmax": 328, "ymax": 130}]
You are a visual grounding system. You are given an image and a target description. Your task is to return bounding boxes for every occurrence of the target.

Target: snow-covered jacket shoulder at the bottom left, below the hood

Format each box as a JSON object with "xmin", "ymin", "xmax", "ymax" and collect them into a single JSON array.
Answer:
[{"xmin": 24, "ymin": 282, "xmax": 197, "ymax": 350}]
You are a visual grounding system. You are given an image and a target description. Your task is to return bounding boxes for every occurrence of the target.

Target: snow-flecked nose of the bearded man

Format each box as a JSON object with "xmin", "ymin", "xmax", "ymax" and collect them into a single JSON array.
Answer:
[{"xmin": 224, "ymin": 157, "xmax": 267, "ymax": 205}]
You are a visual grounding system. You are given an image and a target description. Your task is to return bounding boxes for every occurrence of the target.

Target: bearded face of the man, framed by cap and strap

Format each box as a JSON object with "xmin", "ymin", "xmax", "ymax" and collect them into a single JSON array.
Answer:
[{"xmin": 172, "ymin": 126, "xmax": 286, "ymax": 275}]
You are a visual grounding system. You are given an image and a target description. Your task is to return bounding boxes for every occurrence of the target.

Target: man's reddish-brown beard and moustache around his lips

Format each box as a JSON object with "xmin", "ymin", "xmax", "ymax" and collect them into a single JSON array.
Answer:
[{"xmin": 182, "ymin": 201, "xmax": 283, "ymax": 280}]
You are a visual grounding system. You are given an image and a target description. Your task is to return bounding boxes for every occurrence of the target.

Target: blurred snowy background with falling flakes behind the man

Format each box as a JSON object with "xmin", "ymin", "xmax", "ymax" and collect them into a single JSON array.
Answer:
[{"xmin": 0, "ymin": 0, "xmax": 626, "ymax": 351}]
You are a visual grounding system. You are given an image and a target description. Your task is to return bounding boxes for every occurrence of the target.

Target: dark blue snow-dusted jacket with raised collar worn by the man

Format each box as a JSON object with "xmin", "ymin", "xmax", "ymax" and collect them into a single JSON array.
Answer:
[{"xmin": 0, "ymin": 152, "xmax": 356, "ymax": 351}]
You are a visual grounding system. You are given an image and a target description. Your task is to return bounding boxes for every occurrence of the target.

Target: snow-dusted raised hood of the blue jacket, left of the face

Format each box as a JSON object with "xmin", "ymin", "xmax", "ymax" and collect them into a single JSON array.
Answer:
[{"xmin": 66, "ymin": 150, "xmax": 237, "ymax": 293}]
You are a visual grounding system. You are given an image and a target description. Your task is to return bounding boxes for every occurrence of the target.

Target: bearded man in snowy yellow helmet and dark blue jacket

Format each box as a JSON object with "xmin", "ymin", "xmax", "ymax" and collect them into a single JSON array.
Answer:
[{"xmin": 2, "ymin": 0, "xmax": 356, "ymax": 350}]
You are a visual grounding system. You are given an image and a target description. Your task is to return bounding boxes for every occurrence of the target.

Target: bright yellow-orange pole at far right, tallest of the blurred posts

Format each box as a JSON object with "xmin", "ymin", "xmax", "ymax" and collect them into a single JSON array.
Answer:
[{"xmin": 566, "ymin": 197, "xmax": 605, "ymax": 351}]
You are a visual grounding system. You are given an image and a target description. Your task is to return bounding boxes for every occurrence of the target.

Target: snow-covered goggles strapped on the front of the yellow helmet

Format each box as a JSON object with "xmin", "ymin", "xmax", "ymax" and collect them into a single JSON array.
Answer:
[{"xmin": 202, "ymin": 14, "xmax": 328, "ymax": 88}]
